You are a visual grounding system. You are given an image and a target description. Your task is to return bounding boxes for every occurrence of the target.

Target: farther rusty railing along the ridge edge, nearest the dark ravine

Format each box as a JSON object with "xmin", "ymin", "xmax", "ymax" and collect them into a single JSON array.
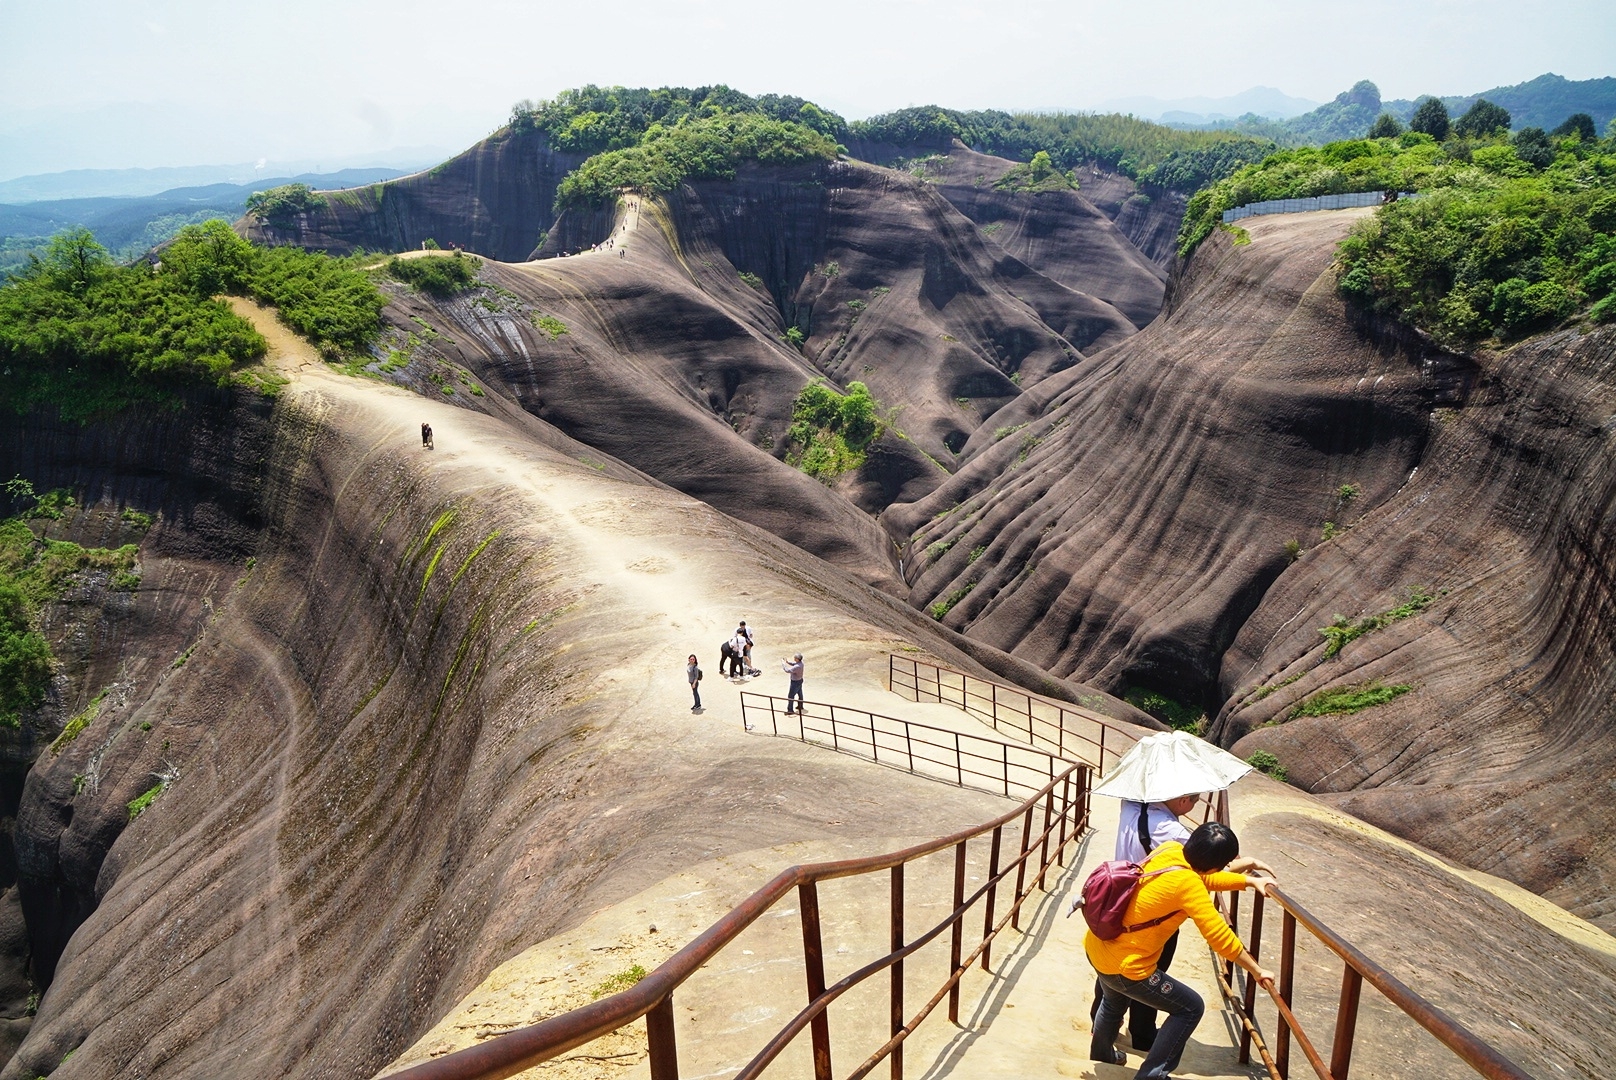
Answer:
[{"xmin": 887, "ymin": 653, "xmax": 1139, "ymax": 776}]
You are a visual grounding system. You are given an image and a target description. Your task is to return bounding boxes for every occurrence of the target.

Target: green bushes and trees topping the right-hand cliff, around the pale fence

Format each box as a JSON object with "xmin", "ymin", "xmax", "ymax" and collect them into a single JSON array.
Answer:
[{"xmin": 1180, "ymin": 117, "xmax": 1616, "ymax": 343}]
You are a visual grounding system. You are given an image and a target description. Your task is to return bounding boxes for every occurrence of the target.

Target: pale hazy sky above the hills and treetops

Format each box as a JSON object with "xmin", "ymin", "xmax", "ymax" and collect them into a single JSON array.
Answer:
[{"xmin": 0, "ymin": 0, "xmax": 1616, "ymax": 179}]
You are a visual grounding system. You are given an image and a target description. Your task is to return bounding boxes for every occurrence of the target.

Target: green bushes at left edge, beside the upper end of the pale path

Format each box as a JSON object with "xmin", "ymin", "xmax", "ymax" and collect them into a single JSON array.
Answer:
[{"xmin": 0, "ymin": 220, "xmax": 386, "ymax": 422}]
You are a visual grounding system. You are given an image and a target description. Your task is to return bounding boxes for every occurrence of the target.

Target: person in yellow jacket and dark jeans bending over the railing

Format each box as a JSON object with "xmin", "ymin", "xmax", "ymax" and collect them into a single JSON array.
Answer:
[{"xmin": 1083, "ymin": 821, "xmax": 1273, "ymax": 1080}]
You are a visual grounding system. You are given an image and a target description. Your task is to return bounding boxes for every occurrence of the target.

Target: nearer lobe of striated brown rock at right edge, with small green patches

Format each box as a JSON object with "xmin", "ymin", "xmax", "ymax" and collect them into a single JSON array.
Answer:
[{"xmin": 1215, "ymin": 320, "xmax": 1616, "ymax": 930}]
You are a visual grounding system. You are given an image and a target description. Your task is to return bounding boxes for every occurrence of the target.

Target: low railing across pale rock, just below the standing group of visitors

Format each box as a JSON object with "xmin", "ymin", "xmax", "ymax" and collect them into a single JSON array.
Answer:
[{"xmin": 740, "ymin": 692, "xmax": 1076, "ymax": 799}]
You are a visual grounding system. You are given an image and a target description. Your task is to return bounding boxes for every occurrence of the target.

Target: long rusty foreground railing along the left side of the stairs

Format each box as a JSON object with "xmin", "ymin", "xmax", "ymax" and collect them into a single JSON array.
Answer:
[{"xmin": 376, "ymin": 765, "xmax": 1091, "ymax": 1080}]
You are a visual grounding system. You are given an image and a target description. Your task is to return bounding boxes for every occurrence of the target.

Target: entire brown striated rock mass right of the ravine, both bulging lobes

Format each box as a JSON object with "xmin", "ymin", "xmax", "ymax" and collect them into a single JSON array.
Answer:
[{"xmin": 884, "ymin": 213, "xmax": 1616, "ymax": 926}]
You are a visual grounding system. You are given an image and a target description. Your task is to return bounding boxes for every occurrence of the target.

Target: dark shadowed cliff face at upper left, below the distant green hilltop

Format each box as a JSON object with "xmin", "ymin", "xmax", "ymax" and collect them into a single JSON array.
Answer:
[{"xmin": 244, "ymin": 129, "xmax": 587, "ymax": 262}]
